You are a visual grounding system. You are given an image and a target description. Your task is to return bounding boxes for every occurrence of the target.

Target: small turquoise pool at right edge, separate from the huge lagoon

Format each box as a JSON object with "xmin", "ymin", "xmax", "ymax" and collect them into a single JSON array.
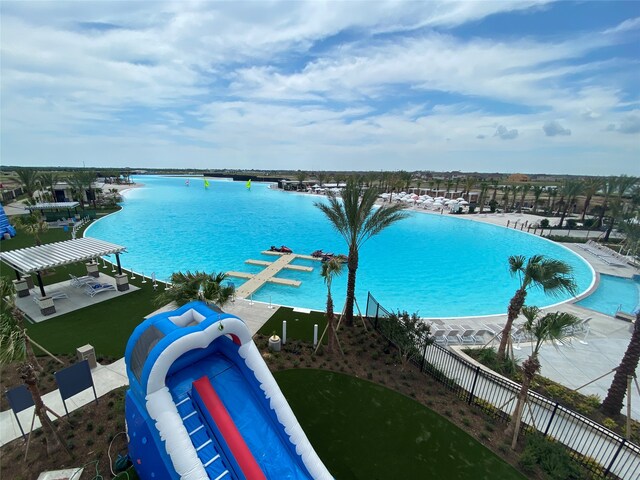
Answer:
[{"xmin": 577, "ymin": 274, "xmax": 640, "ymax": 315}]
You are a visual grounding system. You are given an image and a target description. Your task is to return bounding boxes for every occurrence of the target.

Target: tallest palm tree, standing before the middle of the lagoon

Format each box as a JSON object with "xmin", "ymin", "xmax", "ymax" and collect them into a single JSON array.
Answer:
[{"xmin": 315, "ymin": 180, "xmax": 408, "ymax": 325}]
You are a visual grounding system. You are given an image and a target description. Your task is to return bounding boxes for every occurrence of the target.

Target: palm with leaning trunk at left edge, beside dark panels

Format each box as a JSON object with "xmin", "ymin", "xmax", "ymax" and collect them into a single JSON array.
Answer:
[{"xmin": 0, "ymin": 277, "xmax": 68, "ymax": 455}]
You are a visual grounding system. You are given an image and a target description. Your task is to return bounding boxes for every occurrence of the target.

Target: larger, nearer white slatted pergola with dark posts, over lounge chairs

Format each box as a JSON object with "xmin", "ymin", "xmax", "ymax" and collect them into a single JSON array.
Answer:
[{"xmin": 0, "ymin": 237, "xmax": 126, "ymax": 297}]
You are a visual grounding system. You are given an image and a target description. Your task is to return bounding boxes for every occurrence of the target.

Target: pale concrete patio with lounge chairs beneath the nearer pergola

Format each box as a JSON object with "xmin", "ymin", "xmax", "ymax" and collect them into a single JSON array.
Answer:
[{"xmin": 16, "ymin": 272, "xmax": 140, "ymax": 323}]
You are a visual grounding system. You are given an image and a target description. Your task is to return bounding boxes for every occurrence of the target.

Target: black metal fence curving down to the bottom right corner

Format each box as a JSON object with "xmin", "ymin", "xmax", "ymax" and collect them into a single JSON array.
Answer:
[{"xmin": 366, "ymin": 293, "xmax": 640, "ymax": 480}]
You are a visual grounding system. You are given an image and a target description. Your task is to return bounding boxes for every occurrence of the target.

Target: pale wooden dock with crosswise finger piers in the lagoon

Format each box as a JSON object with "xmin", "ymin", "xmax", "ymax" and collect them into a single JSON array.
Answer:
[{"xmin": 227, "ymin": 250, "xmax": 320, "ymax": 298}]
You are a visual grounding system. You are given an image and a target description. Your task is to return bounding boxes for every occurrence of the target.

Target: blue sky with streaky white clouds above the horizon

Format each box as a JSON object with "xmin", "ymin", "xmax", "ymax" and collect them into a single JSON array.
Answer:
[{"xmin": 0, "ymin": 0, "xmax": 640, "ymax": 175}]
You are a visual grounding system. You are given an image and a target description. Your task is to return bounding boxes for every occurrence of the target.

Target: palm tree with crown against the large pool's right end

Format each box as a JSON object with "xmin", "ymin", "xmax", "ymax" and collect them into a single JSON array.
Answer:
[{"xmin": 498, "ymin": 255, "xmax": 577, "ymax": 361}]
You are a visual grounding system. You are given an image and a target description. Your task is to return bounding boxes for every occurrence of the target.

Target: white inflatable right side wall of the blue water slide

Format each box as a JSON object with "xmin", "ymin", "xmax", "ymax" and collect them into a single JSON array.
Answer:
[{"xmin": 238, "ymin": 341, "xmax": 333, "ymax": 480}]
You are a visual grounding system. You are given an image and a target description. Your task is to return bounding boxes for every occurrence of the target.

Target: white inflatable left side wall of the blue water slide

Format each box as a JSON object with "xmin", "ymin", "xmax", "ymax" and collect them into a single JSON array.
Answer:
[{"xmin": 146, "ymin": 387, "xmax": 209, "ymax": 480}]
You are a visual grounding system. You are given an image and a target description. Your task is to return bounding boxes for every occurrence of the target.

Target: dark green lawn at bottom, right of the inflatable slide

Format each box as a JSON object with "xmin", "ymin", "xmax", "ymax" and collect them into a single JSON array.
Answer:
[{"xmin": 275, "ymin": 370, "xmax": 525, "ymax": 480}]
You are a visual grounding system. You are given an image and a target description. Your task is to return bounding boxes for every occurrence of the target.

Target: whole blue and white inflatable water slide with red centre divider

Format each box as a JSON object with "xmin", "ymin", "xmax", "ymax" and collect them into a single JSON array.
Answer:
[{"xmin": 125, "ymin": 302, "xmax": 333, "ymax": 480}]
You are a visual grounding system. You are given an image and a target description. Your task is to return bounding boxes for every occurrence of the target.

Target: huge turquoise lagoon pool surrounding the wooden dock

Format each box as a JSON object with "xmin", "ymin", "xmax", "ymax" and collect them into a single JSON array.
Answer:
[{"xmin": 86, "ymin": 176, "xmax": 593, "ymax": 317}]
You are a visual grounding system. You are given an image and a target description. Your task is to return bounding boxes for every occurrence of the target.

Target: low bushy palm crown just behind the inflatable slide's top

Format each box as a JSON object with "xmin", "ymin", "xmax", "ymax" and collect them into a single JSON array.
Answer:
[{"xmin": 155, "ymin": 271, "xmax": 235, "ymax": 308}]
